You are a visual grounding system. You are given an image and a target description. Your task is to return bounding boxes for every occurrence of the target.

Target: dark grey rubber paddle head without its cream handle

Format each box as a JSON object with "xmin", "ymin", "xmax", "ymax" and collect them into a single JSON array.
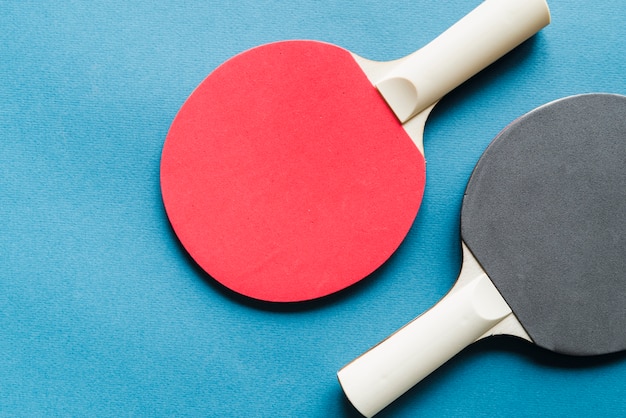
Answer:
[{"xmin": 461, "ymin": 94, "xmax": 626, "ymax": 355}]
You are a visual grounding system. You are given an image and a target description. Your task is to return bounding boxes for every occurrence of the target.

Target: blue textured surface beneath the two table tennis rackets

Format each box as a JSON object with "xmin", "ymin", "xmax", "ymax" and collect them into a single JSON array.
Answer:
[{"xmin": 0, "ymin": 0, "xmax": 626, "ymax": 417}]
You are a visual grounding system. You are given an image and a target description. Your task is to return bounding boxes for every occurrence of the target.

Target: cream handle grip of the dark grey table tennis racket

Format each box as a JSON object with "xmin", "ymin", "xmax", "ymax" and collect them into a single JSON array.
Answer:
[{"xmin": 337, "ymin": 274, "xmax": 511, "ymax": 417}]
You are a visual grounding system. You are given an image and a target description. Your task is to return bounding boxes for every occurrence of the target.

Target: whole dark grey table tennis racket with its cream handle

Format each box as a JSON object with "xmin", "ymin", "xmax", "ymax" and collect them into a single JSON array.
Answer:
[{"xmin": 338, "ymin": 94, "xmax": 626, "ymax": 416}]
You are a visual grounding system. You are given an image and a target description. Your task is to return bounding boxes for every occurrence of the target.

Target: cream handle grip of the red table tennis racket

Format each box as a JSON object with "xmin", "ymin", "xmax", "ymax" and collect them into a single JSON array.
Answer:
[{"xmin": 376, "ymin": 0, "xmax": 550, "ymax": 123}]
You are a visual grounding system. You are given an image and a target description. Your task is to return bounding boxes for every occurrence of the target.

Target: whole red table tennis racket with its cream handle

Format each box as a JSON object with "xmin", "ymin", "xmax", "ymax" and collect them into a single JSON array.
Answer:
[{"xmin": 161, "ymin": 0, "xmax": 550, "ymax": 302}]
